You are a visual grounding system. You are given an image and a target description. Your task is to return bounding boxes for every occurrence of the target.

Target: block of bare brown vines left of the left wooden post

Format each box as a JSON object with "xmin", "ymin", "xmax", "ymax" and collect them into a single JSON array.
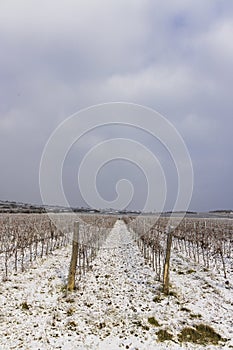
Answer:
[{"xmin": 0, "ymin": 214, "xmax": 73, "ymax": 278}]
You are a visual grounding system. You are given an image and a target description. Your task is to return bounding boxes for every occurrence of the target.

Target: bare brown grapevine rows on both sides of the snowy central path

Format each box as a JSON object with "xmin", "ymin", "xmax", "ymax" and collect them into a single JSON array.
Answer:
[{"xmin": 0, "ymin": 213, "xmax": 233, "ymax": 280}]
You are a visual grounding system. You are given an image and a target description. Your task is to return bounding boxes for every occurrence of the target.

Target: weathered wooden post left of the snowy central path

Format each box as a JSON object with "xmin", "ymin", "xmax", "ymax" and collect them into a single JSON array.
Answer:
[{"xmin": 67, "ymin": 222, "xmax": 79, "ymax": 291}]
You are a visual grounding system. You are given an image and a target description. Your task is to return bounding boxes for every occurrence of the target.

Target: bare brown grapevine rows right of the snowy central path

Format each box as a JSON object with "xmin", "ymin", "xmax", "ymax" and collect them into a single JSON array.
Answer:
[{"xmin": 124, "ymin": 216, "xmax": 233, "ymax": 280}]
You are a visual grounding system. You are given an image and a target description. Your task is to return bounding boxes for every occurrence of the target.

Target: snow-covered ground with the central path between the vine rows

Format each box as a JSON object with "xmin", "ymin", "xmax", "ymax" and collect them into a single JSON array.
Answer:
[{"xmin": 0, "ymin": 221, "xmax": 233, "ymax": 350}]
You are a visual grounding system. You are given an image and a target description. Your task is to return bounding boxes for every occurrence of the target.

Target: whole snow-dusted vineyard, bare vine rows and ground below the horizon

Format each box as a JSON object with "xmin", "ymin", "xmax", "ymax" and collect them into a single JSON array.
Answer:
[{"xmin": 0, "ymin": 213, "xmax": 233, "ymax": 350}]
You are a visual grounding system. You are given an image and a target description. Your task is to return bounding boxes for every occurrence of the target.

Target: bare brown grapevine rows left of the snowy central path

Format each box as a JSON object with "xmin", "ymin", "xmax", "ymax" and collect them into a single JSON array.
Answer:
[{"xmin": 0, "ymin": 213, "xmax": 116, "ymax": 280}]
